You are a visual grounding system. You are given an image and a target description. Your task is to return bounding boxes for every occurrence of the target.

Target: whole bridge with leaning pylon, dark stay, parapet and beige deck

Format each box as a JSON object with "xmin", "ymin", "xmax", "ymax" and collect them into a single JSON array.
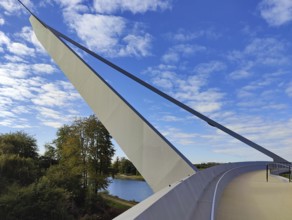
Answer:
[{"xmin": 20, "ymin": 2, "xmax": 292, "ymax": 220}]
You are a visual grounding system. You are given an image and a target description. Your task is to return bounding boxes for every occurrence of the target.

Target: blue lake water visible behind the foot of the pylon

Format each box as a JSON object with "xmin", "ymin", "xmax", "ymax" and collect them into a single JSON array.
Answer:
[{"xmin": 107, "ymin": 179, "xmax": 153, "ymax": 202}]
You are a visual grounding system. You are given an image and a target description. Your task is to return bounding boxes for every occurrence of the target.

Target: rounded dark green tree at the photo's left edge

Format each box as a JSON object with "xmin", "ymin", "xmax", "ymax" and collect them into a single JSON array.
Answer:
[{"xmin": 0, "ymin": 131, "xmax": 40, "ymax": 193}]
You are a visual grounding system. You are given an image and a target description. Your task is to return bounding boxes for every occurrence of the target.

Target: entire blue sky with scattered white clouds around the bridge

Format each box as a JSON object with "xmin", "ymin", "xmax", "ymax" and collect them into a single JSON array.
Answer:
[{"xmin": 0, "ymin": 0, "xmax": 292, "ymax": 163}]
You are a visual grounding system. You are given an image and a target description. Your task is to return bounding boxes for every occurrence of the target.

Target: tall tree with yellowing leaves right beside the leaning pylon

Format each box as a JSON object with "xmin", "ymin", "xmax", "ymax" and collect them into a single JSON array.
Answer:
[{"xmin": 54, "ymin": 115, "xmax": 114, "ymax": 193}]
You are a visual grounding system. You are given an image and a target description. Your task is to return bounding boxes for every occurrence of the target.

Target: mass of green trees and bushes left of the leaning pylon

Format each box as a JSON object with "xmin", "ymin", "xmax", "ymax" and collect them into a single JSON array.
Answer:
[{"xmin": 0, "ymin": 115, "xmax": 121, "ymax": 220}]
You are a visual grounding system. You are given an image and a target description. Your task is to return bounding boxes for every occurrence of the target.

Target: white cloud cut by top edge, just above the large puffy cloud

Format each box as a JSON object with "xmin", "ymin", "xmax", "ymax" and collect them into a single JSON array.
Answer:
[{"xmin": 94, "ymin": 0, "xmax": 171, "ymax": 14}]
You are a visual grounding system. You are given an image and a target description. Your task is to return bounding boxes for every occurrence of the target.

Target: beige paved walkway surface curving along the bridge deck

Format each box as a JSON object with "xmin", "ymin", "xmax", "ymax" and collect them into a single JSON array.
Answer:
[{"xmin": 216, "ymin": 171, "xmax": 292, "ymax": 220}]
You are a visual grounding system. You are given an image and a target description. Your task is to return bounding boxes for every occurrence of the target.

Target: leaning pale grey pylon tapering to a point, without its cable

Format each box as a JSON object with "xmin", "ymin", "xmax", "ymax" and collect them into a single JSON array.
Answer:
[{"xmin": 30, "ymin": 16, "xmax": 196, "ymax": 192}]
